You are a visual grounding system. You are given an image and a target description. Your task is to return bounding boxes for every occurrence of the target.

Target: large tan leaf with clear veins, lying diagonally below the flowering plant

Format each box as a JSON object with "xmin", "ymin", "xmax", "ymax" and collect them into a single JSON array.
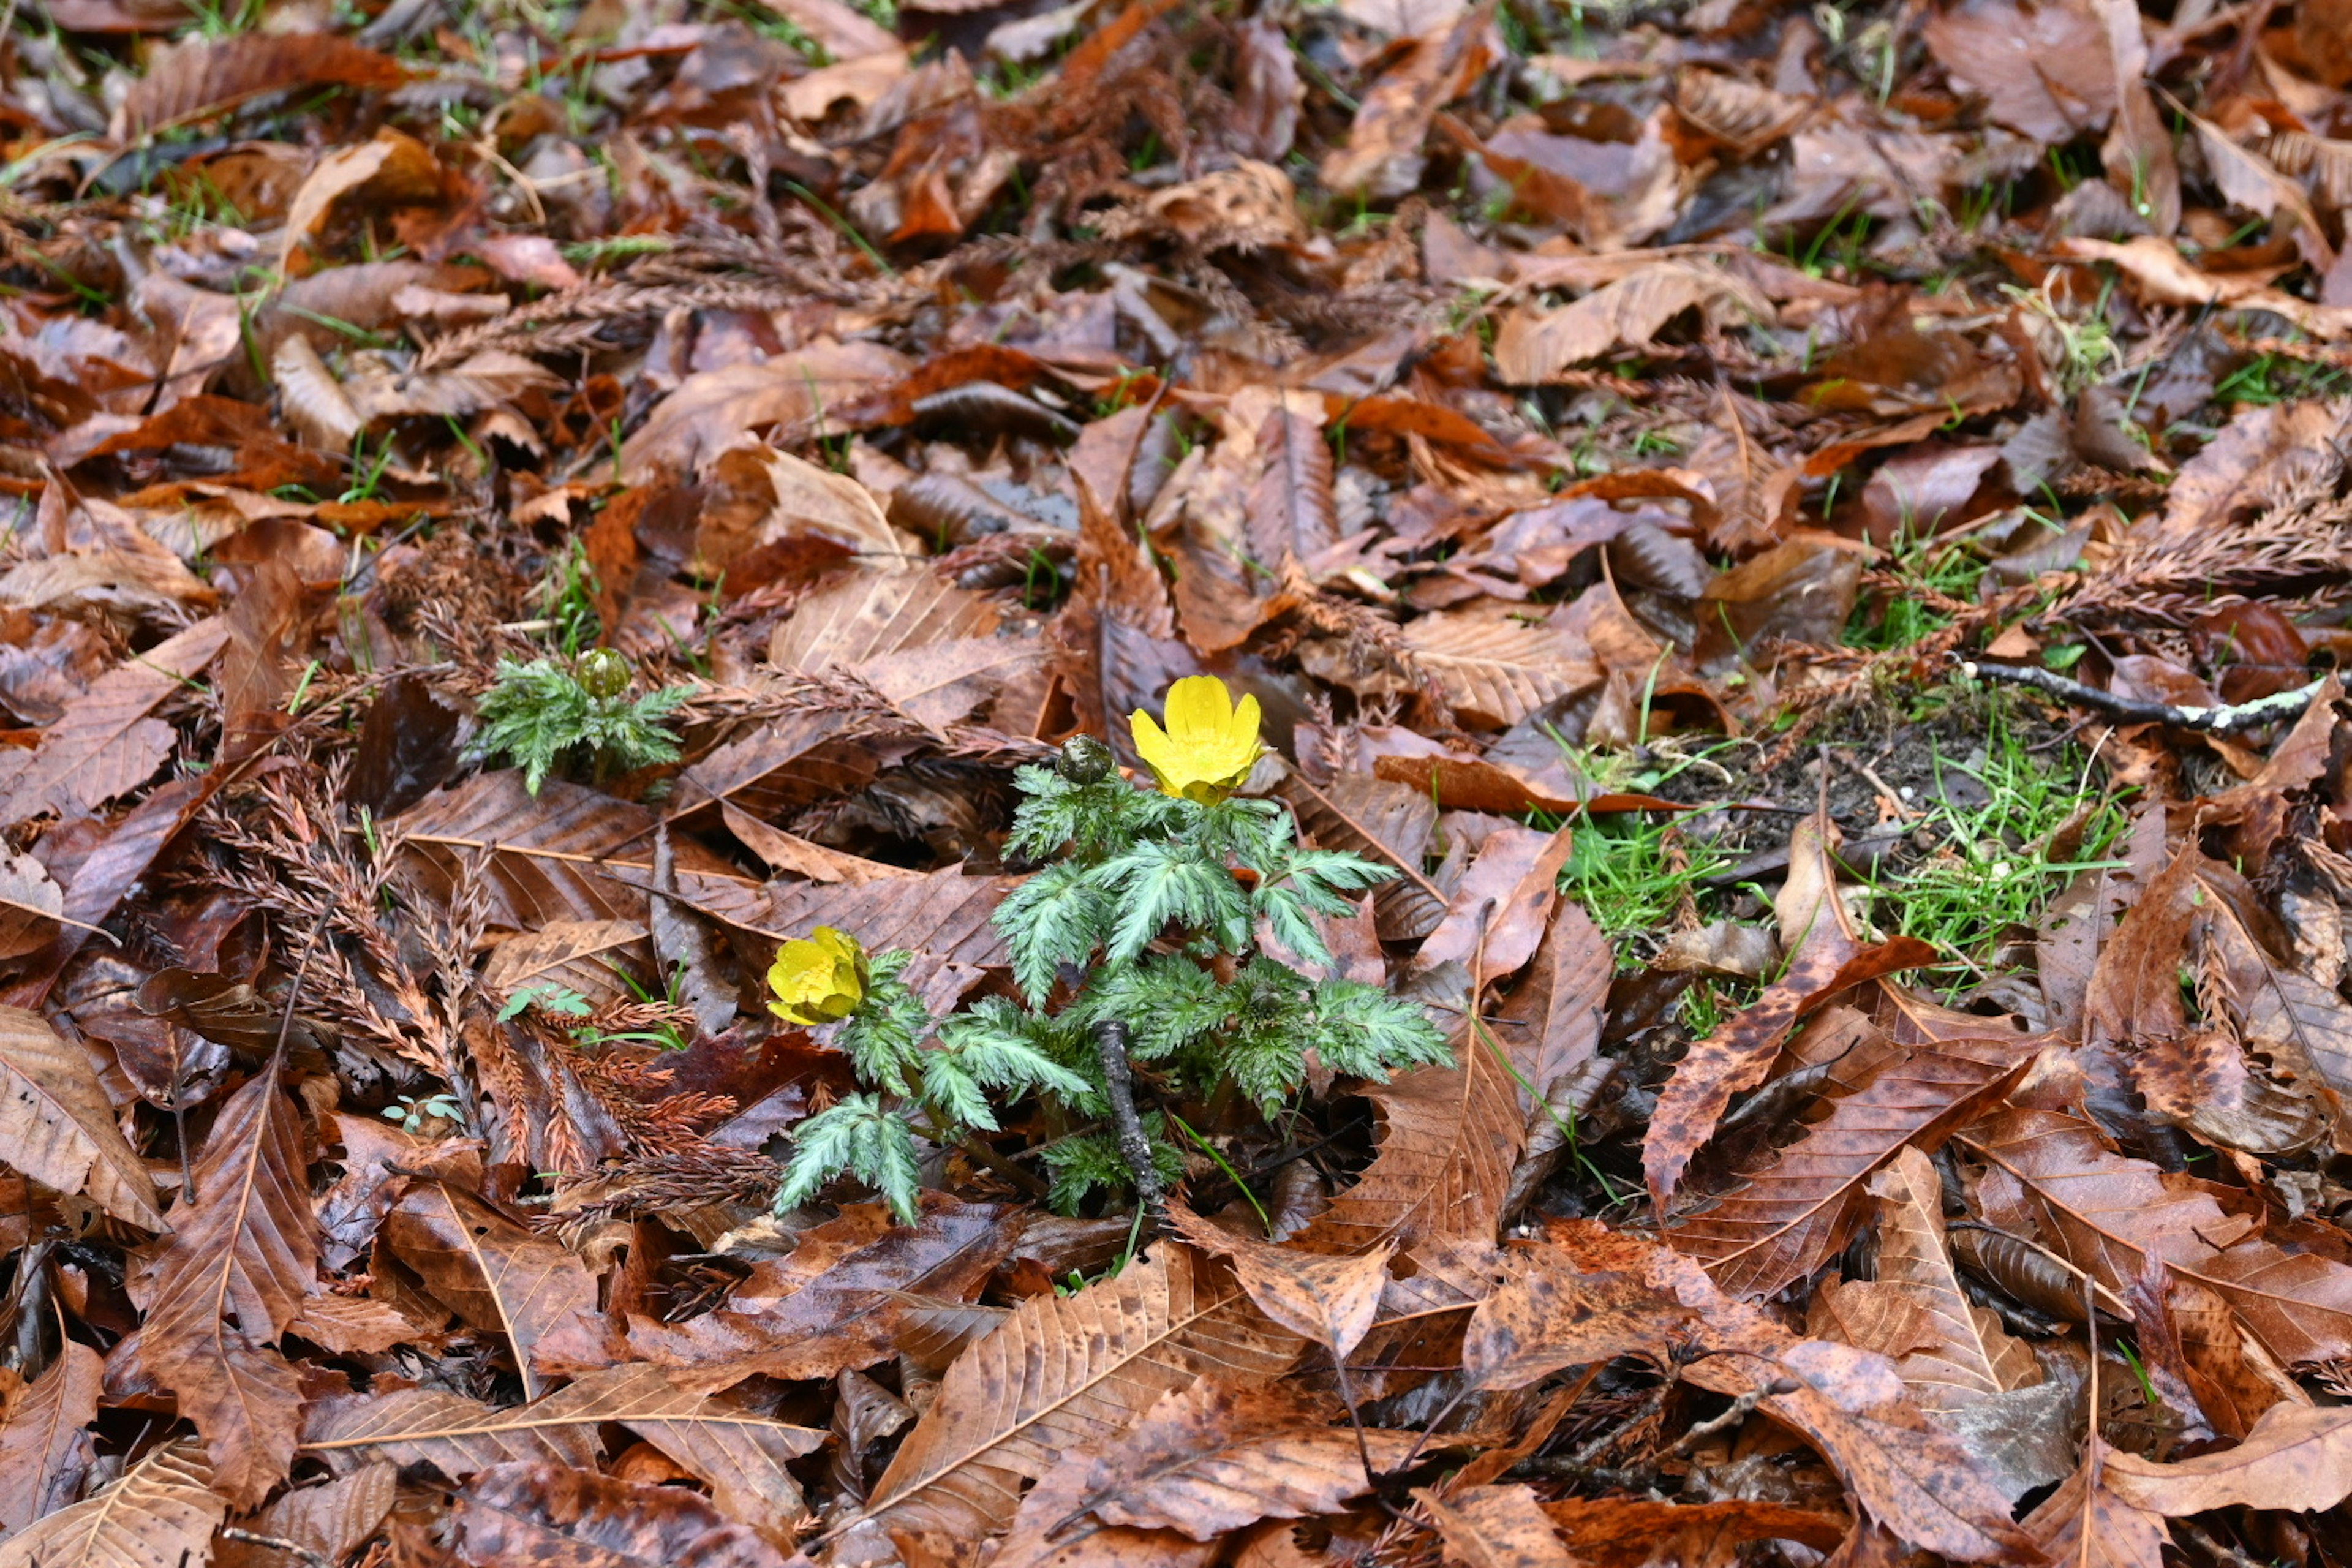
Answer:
[{"xmin": 865, "ymin": 1242, "xmax": 1298, "ymax": 1540}]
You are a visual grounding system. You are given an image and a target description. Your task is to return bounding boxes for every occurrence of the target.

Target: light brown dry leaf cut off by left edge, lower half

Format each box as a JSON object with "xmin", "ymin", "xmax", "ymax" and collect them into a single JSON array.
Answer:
[{"xmin": 0, "ymin": 1006, "xmax": 165, "ymax": 1229}]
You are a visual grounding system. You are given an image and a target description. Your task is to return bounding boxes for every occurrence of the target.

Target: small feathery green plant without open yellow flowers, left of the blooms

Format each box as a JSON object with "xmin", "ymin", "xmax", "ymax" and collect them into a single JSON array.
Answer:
[{"xmin": 473, "ymin": 649, "xmax": 692, "ymax": 794}]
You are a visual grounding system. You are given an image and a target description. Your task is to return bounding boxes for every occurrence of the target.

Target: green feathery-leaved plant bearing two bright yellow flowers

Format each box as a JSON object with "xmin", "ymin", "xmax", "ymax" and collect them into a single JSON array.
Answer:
[{"xmin": 769, "ymin": 677, "xmax": 1449, "ymax": 1218}]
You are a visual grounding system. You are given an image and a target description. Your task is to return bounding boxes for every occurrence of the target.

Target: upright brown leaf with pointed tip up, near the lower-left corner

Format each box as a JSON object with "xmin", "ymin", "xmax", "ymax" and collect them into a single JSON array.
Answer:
[{"xmin": 134, "ymin": 1063, "xmax": 317, "ymax": 1509}]
